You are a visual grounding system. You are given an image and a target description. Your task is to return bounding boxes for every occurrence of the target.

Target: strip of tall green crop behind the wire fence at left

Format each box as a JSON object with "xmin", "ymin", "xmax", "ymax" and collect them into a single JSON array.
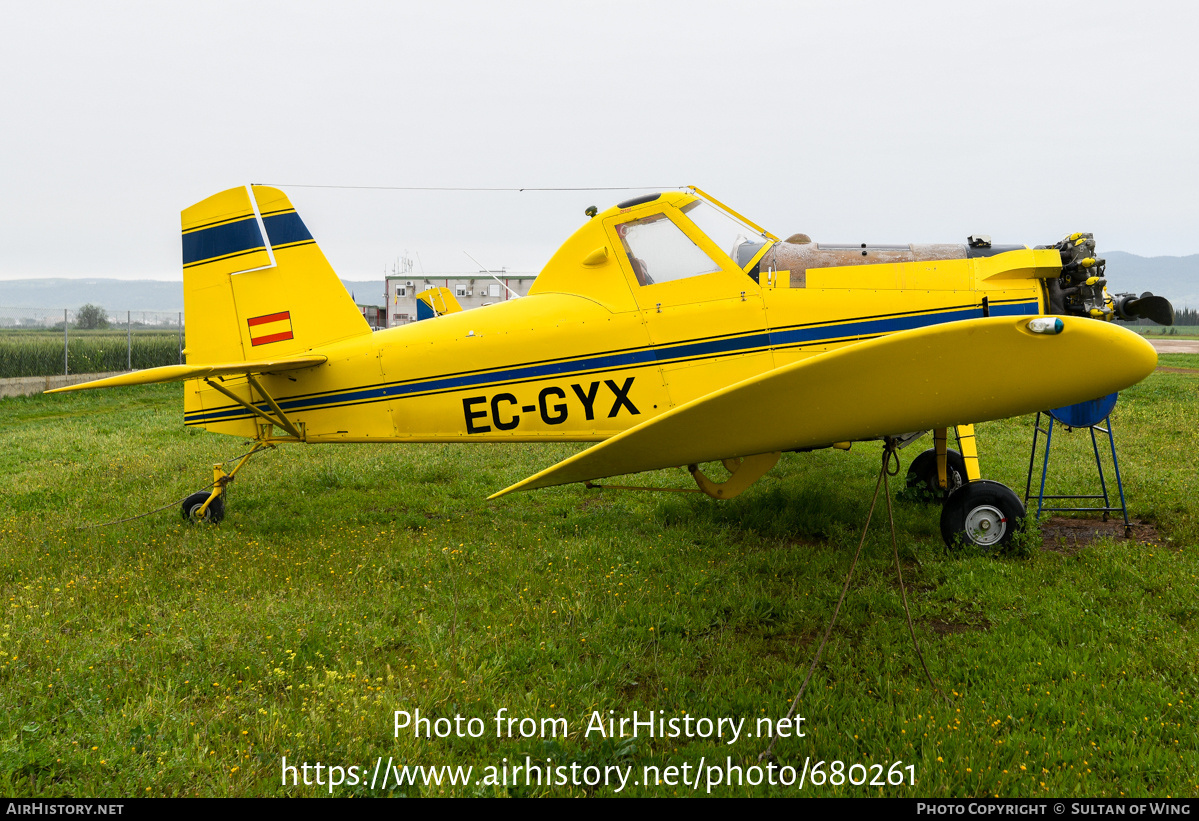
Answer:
[{"xmin": 0, "ymin": 328, "xmax": 179, "ymax": 379}]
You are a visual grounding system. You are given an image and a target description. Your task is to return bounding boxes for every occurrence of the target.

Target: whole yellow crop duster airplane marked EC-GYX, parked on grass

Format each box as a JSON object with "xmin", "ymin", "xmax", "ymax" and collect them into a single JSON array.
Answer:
[{"xmin": 49, "ymin": 186, "xmax": 1173, "ymax": 549}]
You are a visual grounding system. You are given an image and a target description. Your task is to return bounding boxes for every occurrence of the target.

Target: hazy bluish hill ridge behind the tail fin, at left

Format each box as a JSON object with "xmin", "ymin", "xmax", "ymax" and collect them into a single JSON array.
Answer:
[{"xmin": 0, "ymin": 279, "xmax": 384, "ymax": 314}]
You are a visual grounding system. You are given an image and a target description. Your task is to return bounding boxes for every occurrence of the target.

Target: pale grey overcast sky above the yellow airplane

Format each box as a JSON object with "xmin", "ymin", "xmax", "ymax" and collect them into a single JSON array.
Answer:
[{"xmin": 0, "ymin": 0, "xmax": 1199, "ymax": 279}]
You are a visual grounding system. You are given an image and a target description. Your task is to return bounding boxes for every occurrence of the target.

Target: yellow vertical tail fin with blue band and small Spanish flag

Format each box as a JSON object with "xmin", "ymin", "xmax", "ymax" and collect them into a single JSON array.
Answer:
[{"xmin": 181, "ymin": 186, "xmax": 370, "ymax": 366}]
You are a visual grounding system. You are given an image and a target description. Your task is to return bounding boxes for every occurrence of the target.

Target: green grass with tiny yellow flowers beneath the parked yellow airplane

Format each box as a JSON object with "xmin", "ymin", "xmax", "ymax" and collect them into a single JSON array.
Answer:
[{"xmin": 0, "ymin": 355, "xmax": 1199, "ymax": 798}]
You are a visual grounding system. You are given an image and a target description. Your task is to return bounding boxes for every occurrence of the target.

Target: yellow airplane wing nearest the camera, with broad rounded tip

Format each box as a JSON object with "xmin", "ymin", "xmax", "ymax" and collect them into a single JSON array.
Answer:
[{"xmin": 492, "ymin": 316, "xmax": 1157, "ymax": 499}]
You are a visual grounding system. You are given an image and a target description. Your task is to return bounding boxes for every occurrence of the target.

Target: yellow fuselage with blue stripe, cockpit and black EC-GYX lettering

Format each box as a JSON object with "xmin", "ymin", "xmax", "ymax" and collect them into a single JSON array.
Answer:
[{"xmin": 185, "ymin": 194, "xmax": 1061, "ymax": 442}]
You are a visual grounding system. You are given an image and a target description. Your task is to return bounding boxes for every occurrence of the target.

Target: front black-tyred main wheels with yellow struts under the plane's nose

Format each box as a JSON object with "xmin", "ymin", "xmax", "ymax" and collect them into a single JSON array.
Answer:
[{"xmin": 906, "ymin": 425, "xmax": 1024, "ymax": 553}]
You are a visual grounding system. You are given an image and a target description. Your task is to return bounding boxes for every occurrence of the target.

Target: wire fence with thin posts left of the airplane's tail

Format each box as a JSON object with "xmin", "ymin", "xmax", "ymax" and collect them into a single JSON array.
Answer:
[{"xmin": 0, "ymin": 306, "xmax": 183, "ymax": 379}]
